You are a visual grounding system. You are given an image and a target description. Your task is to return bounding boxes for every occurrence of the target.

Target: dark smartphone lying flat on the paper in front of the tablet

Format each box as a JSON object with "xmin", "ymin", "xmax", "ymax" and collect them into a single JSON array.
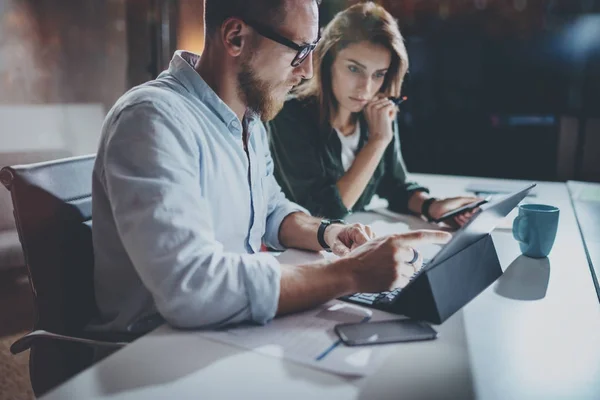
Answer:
[{"xmin": 335, "ymin": 319, "xmax": 437, "ymax": 346}]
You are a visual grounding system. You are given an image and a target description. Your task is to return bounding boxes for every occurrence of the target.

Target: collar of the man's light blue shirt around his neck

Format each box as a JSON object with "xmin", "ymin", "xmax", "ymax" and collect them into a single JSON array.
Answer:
[{"xmin": 159, "ymin": 50, "xmax": 260, "ymax": 135}]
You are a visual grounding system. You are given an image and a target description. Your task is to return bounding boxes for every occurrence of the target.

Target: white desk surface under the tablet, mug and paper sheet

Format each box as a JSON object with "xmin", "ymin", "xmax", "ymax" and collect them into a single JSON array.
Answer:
[{"xmin": 44, "ymin": 175, "xmax": 600, "ymax": 400}]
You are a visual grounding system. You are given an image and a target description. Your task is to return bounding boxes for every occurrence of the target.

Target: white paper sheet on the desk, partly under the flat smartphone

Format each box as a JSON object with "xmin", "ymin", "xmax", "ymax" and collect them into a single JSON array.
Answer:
[{"xmin": 201, "ymin": 300, "xmax": 401, "ymax": 376}]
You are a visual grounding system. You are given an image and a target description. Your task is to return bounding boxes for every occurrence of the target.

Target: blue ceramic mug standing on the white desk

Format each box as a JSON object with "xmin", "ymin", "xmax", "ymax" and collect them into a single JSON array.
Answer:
[{"xmin": 513, "ymin": 204, "xmax": 560, "ymax": 258}]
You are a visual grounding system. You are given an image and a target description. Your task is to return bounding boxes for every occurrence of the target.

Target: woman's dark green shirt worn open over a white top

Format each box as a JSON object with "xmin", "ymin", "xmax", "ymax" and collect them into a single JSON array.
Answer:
[{"xmin": 267, "ymin": 98, "xmax": 428, "ymax": 218}]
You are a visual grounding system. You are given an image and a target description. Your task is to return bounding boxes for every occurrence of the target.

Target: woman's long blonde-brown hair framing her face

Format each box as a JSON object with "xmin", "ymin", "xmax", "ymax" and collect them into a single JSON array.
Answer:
[{"xmin": 295, "ymin": 2, "xmax": 408, "ymax": 123}]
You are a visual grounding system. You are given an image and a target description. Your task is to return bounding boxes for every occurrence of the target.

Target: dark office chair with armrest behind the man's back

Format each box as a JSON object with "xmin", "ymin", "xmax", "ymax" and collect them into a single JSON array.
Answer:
[{"xmin": 0, "ymin": 155, "xmax": 133, "ymax": 396}]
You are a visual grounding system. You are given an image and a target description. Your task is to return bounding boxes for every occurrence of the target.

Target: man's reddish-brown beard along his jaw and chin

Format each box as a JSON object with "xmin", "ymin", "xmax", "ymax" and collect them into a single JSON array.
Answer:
[{"xmin": 237, "ymin": 60, "xmax": 285, "ymax": 122}]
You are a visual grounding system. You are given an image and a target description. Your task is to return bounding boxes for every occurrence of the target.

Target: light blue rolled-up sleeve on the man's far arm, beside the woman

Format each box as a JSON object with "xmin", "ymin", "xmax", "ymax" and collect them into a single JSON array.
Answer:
[{"xmin": 261, "ymin": 127, "xmax": 310, "ymax": 250}]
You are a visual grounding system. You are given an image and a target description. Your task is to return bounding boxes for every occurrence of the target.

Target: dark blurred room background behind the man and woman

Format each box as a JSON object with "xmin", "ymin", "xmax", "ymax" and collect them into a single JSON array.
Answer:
[{"xmin": 0, "ymin": 0, "xmax": 600, "ymax": 181}]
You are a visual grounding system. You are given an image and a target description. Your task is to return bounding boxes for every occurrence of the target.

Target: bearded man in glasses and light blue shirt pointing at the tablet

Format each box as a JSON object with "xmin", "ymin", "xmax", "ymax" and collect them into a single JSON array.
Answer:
[{"xmin": 93, "ymin": 0, "xmax": 449, "ymax": 334}]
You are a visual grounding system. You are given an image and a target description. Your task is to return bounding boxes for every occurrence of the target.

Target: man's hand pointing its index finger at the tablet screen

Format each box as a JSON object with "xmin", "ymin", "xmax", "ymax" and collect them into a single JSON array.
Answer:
[{"xmin": 341, "ymin": 230, "xmax": 452, "ymax": 293}]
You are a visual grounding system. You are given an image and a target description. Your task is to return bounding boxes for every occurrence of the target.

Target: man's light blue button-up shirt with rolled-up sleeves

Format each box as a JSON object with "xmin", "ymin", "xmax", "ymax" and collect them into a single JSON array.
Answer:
[{"xmin": 92, "ymin": 52, "xmax": 306, "ymax": 333}]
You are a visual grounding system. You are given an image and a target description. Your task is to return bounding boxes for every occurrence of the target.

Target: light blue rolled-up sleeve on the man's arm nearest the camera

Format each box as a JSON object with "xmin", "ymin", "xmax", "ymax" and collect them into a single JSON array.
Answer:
[{"xmin": 103, "ymin": 102, "xmax": 280, "ymax": 328}]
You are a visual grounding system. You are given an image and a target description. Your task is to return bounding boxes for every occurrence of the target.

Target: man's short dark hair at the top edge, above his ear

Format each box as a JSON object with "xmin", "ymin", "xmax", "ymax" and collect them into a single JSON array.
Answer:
[{"xmin": 204, "ymin": 0, "xmax": 321, "ymax": 35}]
